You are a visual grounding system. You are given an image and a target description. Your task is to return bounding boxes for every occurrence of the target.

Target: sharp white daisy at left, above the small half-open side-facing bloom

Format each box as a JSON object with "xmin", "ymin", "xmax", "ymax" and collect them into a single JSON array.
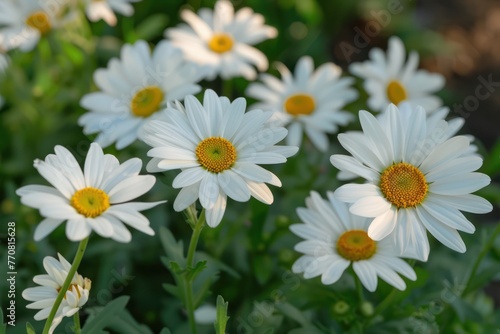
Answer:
[{"xmin": 16, "ymin": 143, "xmax": 164, "ymax": 242}]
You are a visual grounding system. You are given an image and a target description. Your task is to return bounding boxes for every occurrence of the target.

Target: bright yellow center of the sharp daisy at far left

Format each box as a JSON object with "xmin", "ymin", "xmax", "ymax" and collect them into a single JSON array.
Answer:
[{"xmin": 71, "ymin": 187, "xmax": 109, "ymax": 218}]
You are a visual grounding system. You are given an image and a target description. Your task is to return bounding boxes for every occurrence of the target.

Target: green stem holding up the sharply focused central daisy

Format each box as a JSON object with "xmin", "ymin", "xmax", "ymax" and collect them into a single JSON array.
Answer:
[{"xmin": 183, "ymin": 209, "xmax": 205, "ymax": 334}]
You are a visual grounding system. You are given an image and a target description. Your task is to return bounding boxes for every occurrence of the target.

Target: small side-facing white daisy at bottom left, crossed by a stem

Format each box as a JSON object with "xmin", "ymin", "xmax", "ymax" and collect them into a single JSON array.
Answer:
[{"xmin": 22, "ymin": 253, "xmax": 91, "ymax": 333}]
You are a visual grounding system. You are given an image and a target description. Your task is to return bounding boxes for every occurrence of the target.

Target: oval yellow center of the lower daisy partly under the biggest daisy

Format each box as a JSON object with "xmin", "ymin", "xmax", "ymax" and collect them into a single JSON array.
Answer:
[{"xmin": 337, "ymin": 230, "xmax": 377, "ymax": 261}]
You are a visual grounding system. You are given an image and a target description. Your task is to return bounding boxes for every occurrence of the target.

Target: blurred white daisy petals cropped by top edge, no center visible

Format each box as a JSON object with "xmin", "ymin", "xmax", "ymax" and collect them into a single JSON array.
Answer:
[{"xmin": 85, "ymin": 0, "xmax": 141, "ymax": 26}]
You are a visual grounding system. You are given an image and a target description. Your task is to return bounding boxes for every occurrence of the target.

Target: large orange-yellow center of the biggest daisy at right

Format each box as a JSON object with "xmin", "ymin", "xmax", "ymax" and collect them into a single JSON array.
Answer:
[{"xmin": 380, "ymin": 162, "xmax": 429, "ymax": 208}]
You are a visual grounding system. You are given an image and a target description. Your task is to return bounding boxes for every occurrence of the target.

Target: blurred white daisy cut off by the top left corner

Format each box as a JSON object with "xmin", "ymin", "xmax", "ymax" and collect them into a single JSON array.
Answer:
[{"xmin": 0, "ymin": 0, "xmax": 66, "ymax": 52}]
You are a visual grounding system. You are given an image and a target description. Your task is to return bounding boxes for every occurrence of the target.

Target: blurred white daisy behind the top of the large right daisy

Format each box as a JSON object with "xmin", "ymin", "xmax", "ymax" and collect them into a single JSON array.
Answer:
[{"xmin": 349, "ymin": 36, "xmax": 444, "ymax": 113}]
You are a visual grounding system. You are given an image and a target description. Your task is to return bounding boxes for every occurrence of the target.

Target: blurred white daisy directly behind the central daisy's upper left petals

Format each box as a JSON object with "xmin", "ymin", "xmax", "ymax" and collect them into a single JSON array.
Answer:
[{"xmin": 78, "ymin": 41, "xmax": 204, "ymax": 149}]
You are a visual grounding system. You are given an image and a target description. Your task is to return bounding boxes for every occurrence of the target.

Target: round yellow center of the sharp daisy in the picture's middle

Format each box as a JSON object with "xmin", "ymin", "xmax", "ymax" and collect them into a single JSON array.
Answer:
[{"xmin": 196, "ymin": 137, "xmax": 236, "ymax": 173}]
